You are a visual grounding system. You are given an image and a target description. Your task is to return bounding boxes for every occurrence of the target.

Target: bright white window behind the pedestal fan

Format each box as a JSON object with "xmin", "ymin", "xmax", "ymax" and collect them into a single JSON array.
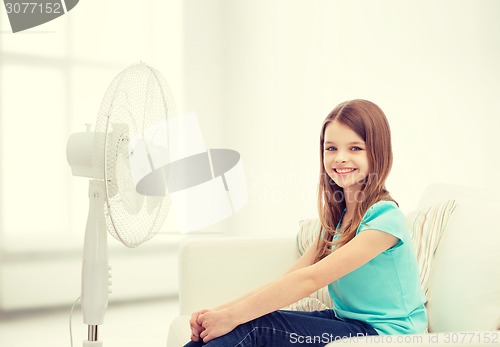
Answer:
[{"xmin": 0, "ymin": 0, "xmax": 182, "ymax": 251}]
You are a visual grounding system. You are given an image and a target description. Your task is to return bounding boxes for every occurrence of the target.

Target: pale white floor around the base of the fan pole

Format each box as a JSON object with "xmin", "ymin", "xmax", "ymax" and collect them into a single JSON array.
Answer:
[{"xmin": 0, "ymin": 298, "xmax": 178, "ymax": 347}]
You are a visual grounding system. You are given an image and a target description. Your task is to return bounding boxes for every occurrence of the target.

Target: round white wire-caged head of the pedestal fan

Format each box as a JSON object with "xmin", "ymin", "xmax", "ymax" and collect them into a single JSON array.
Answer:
[{"xmin": 92, "ymin": 63, "xmax": 175, "ymax": 247}]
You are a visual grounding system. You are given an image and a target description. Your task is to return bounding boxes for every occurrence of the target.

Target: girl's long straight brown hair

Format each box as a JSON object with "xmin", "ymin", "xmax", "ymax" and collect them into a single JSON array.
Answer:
[{"xmin": 315, "ymin": 99, "xmax": 394, "ymax": 262}]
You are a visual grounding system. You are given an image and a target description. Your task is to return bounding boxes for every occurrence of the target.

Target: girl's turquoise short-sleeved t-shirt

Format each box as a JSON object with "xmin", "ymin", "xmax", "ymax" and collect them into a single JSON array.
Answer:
[{"xmin": 328, "ymin": 201, "xmax": 427, "ymax": 335}]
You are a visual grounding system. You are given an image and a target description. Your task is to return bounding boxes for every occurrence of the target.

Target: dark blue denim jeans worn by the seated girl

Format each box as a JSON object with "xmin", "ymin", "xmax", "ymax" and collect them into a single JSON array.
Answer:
[{"xmin": 184, "ymin": 310, "xmax": 377, "ymax": 347}]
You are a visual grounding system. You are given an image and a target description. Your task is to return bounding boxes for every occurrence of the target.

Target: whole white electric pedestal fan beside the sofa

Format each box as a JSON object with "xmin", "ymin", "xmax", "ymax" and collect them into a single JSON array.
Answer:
[{"xmin": 67, "ymin": 63, "xmax": 175, "ymax": 346}]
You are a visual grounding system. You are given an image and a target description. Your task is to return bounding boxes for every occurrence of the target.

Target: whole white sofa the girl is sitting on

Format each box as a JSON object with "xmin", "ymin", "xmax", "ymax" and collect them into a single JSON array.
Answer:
[{"xmin": 167, "ymin": 184, "xmax": 500, "ymax": 347}]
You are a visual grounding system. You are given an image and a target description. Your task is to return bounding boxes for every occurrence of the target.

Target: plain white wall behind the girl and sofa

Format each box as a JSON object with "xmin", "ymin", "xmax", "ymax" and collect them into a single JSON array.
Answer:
[{"xmin": 184, "ymin": 0, "xmax": 500, "ymax": 239}]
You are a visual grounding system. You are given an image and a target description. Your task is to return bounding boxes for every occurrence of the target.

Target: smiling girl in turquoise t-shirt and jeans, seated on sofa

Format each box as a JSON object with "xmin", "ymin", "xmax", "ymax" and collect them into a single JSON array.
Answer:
[{"xmin": 186, "ymin": 100, "xmax": 427, "ymax": 347}]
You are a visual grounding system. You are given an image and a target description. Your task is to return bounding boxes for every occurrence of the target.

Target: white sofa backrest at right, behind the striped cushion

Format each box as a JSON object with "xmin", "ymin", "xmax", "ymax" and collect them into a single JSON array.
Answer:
[{"xmin": 419, "ymin": 184, "xmax": 500, "ymax": 332}]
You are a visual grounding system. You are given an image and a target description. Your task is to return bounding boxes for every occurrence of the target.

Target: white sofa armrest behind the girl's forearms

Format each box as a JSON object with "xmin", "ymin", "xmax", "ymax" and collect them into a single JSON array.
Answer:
[{"xmin": 179, "ymin": 237, "xmax": 299, "ymax": 315}]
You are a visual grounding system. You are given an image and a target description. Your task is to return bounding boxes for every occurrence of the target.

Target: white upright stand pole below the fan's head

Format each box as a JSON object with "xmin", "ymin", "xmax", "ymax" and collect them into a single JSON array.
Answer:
[{"xmin": 81, "ymin": 180, "xmax": 110, "ymax": 347}]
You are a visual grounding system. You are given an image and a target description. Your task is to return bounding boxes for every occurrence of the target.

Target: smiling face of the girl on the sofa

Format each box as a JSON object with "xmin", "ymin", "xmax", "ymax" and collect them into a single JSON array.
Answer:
[{"xmin": 323, "ymin": 120, "xmax": 369, "ymax": 191}]
